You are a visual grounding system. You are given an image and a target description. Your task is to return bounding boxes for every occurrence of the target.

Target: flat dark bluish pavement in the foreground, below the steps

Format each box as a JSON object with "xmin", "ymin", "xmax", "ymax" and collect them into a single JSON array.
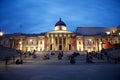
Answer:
[{"xmin": 0, "ymin": 64, "xmax": 120, "ymax": 80}]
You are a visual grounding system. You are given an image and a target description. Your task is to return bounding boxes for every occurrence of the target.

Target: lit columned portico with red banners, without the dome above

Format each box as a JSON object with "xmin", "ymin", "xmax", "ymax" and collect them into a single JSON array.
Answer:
[{"xmin": 45, "ymin": 31, "xmax": 75, "ymax": 51}]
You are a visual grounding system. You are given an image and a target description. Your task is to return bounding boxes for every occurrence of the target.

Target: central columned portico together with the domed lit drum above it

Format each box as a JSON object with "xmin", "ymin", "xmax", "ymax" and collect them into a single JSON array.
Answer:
[{"xmin": 45, "ymin": 19, "xmax": 75, "ymax": 51}]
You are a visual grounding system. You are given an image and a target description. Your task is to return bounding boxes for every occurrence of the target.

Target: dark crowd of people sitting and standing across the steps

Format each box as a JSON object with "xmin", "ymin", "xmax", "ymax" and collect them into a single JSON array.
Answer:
[{"xmin": 1, "ymin": 49, "xmax": 119, "ymax": 65}]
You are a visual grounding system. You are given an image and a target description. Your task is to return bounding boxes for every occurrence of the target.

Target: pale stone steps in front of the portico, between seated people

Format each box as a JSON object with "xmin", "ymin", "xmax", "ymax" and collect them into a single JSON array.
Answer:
[{"xmin": 20, "ymin": 52, "xmax": 86, "ymax": 65}]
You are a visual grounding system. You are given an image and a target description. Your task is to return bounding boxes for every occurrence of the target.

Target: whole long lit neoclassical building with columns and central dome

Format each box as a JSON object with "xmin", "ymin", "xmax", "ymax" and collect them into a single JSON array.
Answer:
[{"xmin": 1, "ymin": 18, "xmax": 120, "ymax": 52}]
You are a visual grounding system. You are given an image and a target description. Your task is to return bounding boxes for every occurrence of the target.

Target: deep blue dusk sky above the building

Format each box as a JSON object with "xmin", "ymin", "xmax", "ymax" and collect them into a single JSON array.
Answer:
[{"xmin": 0, "ymin": 0, "xmax": 120, "ymax": 33}]
